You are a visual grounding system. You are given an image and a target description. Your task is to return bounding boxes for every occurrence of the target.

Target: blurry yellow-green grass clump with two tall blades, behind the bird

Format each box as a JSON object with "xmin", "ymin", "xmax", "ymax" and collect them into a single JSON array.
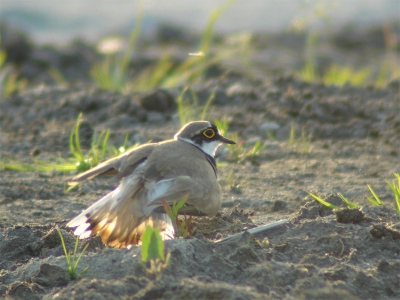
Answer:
[{"xmin": 90, "ymin": 0, "xmax": 236, "ymax": 91}]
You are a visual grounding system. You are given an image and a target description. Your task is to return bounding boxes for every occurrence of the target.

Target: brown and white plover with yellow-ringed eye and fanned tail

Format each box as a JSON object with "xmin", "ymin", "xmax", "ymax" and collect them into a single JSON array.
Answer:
[{"xmin": 67, "ymin": 121, "xmax": 236, "ymax": 248}]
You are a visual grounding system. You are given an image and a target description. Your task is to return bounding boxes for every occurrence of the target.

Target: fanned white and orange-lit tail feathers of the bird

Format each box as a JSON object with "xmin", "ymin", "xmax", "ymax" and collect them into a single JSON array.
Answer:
[{"xmin": 67, "ymin": 162, "xmax": 175, "ymax": 247}]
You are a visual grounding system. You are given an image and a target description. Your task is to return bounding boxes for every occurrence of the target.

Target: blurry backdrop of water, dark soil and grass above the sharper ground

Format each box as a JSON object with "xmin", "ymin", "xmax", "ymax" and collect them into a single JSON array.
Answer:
[{"xmin": 0, "ymin": 0, "xmax": 400, "ymax": 96}]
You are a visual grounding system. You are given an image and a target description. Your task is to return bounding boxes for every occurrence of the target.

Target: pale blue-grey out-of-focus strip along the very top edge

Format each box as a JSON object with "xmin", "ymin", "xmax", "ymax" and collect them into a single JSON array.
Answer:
[{"xmin": 0, "ymin": 0, "xmax": 400, "ymax": 44}]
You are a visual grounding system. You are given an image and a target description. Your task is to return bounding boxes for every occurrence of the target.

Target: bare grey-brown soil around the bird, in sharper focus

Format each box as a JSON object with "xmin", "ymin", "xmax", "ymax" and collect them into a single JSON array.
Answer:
[{"xmin": 0, "ymin": 24, "xmax": 400, "ymax": 299}]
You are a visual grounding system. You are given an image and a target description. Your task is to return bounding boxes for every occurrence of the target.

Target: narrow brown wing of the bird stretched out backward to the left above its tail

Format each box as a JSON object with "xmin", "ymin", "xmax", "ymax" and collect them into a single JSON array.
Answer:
[{"xmin": 68, "ymin": 143, "xmax": 157, "ymax": 185}]
